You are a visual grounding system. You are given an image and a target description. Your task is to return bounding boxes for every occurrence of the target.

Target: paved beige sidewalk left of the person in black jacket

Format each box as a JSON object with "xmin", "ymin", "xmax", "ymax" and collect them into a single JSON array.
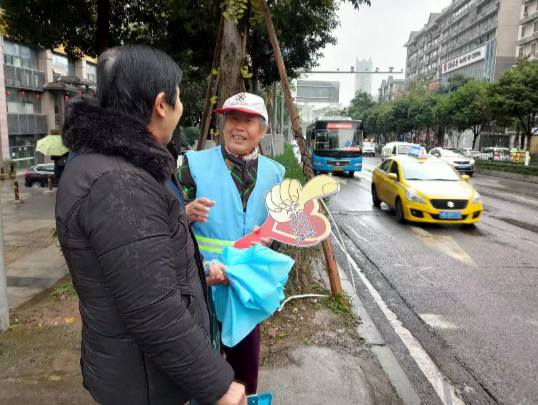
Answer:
[{"xmin": 0, "ymin": 175, "xmax": 68, "ymax": 310}]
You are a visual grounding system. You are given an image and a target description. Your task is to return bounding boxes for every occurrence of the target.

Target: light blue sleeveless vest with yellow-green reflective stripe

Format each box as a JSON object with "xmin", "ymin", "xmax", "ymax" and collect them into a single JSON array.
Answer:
[{"xmin": 187, "ymin": 146, "xmax": 285, "ymax": 260}]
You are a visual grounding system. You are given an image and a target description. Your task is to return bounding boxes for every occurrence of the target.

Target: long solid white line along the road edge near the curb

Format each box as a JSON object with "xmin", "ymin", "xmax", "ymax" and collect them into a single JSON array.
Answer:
[{"xmin": 328, "ymin": 235, "xmax": 465, "ymax": 405}]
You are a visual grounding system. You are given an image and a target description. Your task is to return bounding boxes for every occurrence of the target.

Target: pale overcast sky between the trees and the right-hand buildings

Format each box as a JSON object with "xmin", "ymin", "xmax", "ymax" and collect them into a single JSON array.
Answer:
[{"xmin": 298, "ymin": 0, "xmax": 450, "ymax": 106}]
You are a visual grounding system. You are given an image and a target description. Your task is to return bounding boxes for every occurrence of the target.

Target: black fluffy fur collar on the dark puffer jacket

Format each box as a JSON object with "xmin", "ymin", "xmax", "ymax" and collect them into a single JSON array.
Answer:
[{"xmin": 62, "ymin": 96, "xmax": 175, "ymax": 182}]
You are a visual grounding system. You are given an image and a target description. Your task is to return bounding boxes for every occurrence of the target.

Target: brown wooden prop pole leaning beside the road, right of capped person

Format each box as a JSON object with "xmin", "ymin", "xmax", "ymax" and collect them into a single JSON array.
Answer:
[{"xmin": 260, "ymin": 0, "xmax": 342, "ymax": 297}]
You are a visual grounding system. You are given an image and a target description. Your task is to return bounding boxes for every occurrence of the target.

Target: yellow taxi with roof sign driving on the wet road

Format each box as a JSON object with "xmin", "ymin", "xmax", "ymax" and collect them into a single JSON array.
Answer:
[{"xmin": 372, "ymin": 147, "xmax": 483, "ymax": 225}]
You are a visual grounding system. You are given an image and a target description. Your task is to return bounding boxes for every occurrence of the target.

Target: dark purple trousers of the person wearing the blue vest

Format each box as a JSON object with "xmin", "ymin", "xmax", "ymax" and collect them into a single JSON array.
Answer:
[{"xmin": 220, "ymin": 325, "xmax": 261, "ymax": 395}]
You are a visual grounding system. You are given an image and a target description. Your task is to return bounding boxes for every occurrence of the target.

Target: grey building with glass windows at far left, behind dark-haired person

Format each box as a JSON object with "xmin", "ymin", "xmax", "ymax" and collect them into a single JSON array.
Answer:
[{"xmin": 0, "ymin": 37, "xmax": 97, "ymax": 168}]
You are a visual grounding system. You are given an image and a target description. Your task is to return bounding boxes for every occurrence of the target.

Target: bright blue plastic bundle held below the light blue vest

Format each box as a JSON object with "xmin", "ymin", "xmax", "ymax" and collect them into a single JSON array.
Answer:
[{"xmin": 213, "ymin": 245, "xmax": 294, "ymax": 347}]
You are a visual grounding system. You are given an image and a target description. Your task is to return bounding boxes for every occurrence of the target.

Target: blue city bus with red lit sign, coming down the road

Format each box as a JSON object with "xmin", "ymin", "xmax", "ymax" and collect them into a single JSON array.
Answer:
[{"xmin": 306, "ymin": 117, "xmax": 364, "ymax": 176}]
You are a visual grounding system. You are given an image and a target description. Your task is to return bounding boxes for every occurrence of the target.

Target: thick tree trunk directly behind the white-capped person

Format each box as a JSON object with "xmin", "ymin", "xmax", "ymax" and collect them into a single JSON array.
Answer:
[{"xmin": 217, "ymin": 13, "xmax": 245, "ymax": 144}]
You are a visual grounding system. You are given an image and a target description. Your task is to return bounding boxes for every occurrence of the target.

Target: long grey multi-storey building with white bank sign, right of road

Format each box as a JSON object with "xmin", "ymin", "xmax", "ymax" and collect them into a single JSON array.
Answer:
[{"xmin": 405, "ymin": 0, "xmax": 528, "ymax": 89}]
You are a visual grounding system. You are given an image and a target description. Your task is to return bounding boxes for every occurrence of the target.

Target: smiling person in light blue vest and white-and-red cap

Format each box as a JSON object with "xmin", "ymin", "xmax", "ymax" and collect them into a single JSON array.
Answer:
[{"xmin": 179, "ymin": 93, "xmax": 285, "ymax": 394}]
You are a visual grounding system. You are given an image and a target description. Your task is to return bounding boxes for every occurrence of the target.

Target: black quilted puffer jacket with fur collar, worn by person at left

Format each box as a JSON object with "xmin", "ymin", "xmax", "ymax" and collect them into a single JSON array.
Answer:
[{"xmin": 56, "ymin": 97, "xmax": 233, "ymax": 405}]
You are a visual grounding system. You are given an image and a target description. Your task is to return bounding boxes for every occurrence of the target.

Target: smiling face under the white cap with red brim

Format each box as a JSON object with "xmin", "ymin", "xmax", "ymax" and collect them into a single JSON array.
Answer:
[{"xmin": 224, "ymin": 110, "xmax": 267, "ymax": 156}]
